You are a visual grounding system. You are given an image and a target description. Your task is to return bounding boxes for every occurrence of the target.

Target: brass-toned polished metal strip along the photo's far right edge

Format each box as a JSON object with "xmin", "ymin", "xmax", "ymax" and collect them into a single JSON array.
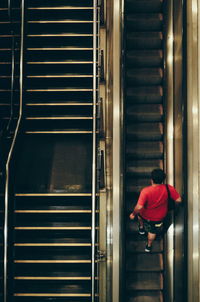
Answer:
[{"xmin": 187, "ymin": 0, "xmax": 200, "ymax": 302}]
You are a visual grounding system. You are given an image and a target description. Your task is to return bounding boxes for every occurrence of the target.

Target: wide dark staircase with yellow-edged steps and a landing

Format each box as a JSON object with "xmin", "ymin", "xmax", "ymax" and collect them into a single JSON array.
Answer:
[{"xmin": 0, "ymin": 0, "xmax": 99, "ymax": 302}]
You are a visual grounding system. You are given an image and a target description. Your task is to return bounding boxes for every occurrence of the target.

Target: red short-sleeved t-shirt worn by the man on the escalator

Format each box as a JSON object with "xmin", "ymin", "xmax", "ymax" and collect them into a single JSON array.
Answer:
[{"xmin": 138, "ymin": 184, "xmax": 180, "ymax": 221}]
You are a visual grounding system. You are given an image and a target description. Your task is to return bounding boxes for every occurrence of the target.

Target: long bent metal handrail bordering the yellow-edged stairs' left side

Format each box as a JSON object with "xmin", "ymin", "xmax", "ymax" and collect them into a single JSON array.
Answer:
[{"xmin": 3, "ymin": 0, "xmax": 24, "ymax": 302}]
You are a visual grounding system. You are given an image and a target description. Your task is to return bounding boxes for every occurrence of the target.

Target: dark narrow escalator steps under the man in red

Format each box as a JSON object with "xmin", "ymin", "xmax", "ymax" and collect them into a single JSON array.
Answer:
[{"xmin": 124, "ymin": 0, "xmax": 164, "ymax": 302}]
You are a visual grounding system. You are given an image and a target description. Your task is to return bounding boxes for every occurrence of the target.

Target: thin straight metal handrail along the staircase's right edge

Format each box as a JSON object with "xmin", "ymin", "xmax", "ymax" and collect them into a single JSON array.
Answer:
[{"xmin": 91, "ymin": 0, "xmax": 98, "ymax": 302}]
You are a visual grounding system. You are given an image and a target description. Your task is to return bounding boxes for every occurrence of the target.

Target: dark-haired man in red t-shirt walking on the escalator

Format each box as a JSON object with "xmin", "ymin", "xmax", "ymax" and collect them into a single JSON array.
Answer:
[{"xmin": 130, "ymin": 169, "xmax": 181, "ymax": 252}]
